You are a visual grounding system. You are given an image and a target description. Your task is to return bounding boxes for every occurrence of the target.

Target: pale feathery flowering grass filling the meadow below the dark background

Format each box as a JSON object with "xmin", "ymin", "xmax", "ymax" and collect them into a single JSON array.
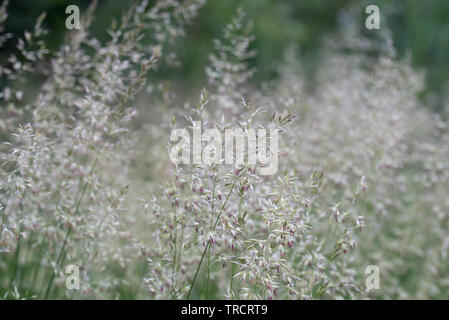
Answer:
[{"xmin": 0, "ymin": 0, "xmax": 449, "ymax": 299}]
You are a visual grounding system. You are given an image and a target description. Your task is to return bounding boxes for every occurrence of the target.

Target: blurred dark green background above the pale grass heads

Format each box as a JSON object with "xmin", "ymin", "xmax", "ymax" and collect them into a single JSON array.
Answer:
[{"xmin": 0, "ymin": 0, "xmax": 449, "ymax": 111}]
